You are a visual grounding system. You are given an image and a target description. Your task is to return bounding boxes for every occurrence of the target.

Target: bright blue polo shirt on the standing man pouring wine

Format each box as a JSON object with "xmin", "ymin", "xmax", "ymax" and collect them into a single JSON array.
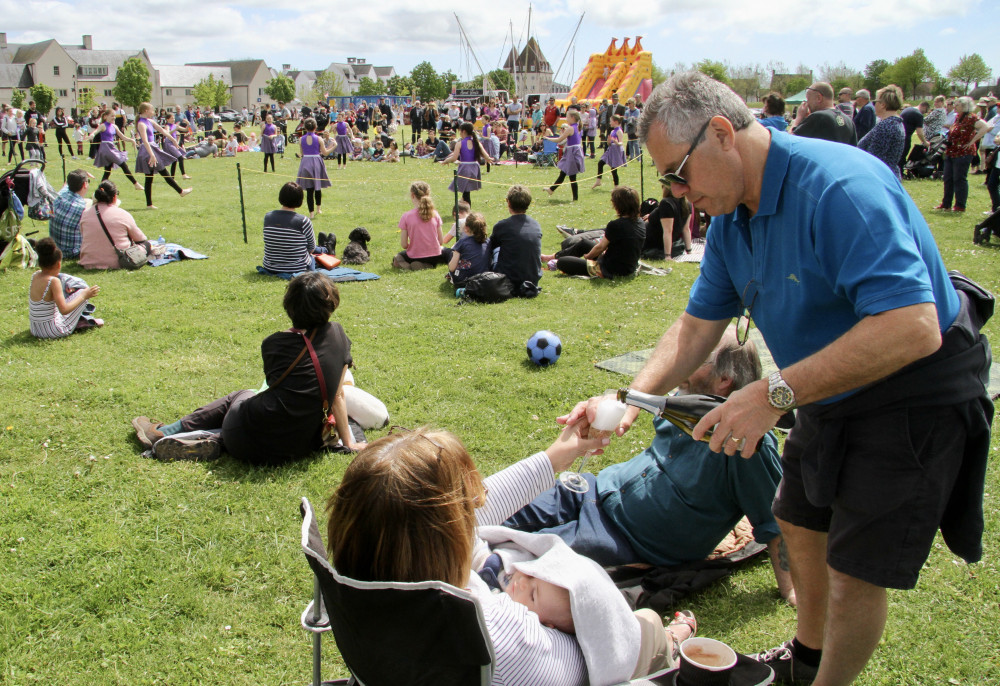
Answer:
[{"xmin": 687, "ymin": 130, "xmax": 959, "ymax": 402}]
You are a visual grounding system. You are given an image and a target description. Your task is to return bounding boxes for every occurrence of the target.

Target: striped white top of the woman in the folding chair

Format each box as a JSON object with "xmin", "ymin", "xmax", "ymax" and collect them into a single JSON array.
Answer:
[{"xmin": 469, "ymin": 453, "xmax": 587, "ymax": 686}]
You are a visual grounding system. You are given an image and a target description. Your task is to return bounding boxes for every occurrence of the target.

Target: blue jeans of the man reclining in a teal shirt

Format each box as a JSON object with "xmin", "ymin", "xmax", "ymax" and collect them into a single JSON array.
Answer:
[{"xmin": 503, "ymin": 473, "xmax": 642, "ymax": 567}]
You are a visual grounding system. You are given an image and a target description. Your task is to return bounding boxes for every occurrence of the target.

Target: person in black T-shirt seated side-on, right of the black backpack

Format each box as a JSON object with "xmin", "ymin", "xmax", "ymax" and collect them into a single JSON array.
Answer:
[{"xmin": 541, "ymin": 186, "xmax": 646, "ymax": 279}]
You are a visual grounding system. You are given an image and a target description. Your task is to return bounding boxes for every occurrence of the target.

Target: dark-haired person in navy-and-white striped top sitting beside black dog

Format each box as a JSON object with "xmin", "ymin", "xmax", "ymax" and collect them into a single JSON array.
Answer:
[{"xmin": 264, "ymin": 187, "xmax": 316, "ymax": 274}]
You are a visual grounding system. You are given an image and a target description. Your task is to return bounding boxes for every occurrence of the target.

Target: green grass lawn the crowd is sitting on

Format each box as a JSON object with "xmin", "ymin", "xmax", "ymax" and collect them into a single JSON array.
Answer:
[{"xmin": 0, "ymin": 136, "xmax": 1000, "ymax": 686}]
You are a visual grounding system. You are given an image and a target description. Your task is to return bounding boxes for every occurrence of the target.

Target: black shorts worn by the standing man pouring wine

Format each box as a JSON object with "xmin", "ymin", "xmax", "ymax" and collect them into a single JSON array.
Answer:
[{"xmin": 772, "ymin": 406, "xmax": 966, "ymax": 589}]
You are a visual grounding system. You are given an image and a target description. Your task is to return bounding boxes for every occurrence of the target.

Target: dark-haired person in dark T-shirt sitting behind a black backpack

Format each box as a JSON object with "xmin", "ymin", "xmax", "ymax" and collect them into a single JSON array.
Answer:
[{"xmin": 489, "ymin": 185, "xmax": 542, "ymax": 297}]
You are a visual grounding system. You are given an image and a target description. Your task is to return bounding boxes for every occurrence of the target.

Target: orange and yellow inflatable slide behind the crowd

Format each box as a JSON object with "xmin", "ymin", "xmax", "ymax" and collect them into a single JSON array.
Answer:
[{"xmin": 556, "ymin": 36, "xmax": 653, "ymax": 106}]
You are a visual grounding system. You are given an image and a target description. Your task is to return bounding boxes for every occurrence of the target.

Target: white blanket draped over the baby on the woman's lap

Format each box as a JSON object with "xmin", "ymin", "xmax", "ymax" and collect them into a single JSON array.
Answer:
[{"xmin": 478, "ymin": 526, "xmax": 641, "ymax": 686}]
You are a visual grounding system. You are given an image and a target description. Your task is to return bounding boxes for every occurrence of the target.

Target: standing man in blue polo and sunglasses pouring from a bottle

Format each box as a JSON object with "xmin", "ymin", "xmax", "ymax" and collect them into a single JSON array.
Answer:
[{"xmin": 563, "ymin": 72, "xmax": 993, "ymax": 686}]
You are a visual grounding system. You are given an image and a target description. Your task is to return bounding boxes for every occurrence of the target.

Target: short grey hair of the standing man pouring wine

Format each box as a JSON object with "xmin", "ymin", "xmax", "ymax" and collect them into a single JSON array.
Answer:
[{"xmin": 639, "ymin": 71, "xmax": 754, "ymax": 145}]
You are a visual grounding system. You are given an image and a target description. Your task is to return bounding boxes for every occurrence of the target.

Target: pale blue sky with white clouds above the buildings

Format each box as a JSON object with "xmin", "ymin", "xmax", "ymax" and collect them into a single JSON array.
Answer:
[{"xmin": 0, "ymin": 0, "xmax": 1000, "ymax": 90}]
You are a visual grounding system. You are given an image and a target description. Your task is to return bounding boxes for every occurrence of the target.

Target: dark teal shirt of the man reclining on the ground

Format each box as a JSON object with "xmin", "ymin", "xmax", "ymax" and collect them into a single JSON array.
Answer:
[{"xmin": 597, "ymin": 419, "xmax": 781, "ymax": 565}]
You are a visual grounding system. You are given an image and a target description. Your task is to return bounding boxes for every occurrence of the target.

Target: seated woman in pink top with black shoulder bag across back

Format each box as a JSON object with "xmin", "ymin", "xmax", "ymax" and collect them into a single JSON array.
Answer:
[{"xmin": 80, "ymin": 179, "xmax": 153, "ymax": 269}]
